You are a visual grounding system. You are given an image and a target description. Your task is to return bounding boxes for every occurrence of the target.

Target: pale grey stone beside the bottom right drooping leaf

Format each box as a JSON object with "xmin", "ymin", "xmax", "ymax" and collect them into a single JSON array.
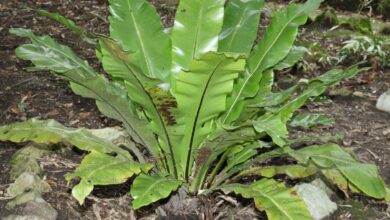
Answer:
[{"xmin": 295, "ymin": 183, "xmax": 337, "ymax": 220}]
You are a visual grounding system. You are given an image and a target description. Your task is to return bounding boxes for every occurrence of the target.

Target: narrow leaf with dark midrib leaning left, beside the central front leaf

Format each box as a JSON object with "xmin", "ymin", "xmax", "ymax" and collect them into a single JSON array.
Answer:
[{"xmin": 101, "ymin": 39, "xmax": 177, "ymax": 175}]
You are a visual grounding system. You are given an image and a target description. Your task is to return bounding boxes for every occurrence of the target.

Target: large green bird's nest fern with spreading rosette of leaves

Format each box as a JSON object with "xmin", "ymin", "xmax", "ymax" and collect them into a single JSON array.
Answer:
[{"xmin": 0, "ymin": 0, "xmax": 386, "ymax": 219}]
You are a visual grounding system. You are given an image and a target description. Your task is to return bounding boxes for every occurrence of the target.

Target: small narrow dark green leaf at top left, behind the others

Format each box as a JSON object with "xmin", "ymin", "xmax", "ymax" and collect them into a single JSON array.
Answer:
[{"xmin": 32, "ymin": 9, "xmax": 96, "ymax": 45}]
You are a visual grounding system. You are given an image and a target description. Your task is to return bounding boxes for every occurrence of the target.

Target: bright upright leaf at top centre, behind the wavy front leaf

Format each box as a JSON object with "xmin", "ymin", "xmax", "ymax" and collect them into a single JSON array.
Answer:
[{"xmin": 172, "ymin": 0, "xmax": 225, "ymax": 74}]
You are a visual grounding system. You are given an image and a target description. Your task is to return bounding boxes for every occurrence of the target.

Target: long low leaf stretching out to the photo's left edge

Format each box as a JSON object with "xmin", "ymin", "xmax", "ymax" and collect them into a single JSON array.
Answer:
[{"xmin": 0, "ymin": 118, "xmax": 131, "ymax": 160}]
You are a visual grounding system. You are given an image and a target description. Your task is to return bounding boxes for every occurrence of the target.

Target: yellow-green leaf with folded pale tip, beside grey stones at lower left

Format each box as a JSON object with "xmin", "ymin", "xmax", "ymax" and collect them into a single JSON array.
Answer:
[{"xmin": 66, "ymin": 152, "xmax": 153, "ymax": 205}]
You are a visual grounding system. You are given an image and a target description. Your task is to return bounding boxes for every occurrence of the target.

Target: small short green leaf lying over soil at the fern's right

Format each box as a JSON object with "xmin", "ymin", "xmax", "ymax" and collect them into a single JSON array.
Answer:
[{"xmin": 290, "ymin": 114, "xmax": 335, "ymax": 128}]
